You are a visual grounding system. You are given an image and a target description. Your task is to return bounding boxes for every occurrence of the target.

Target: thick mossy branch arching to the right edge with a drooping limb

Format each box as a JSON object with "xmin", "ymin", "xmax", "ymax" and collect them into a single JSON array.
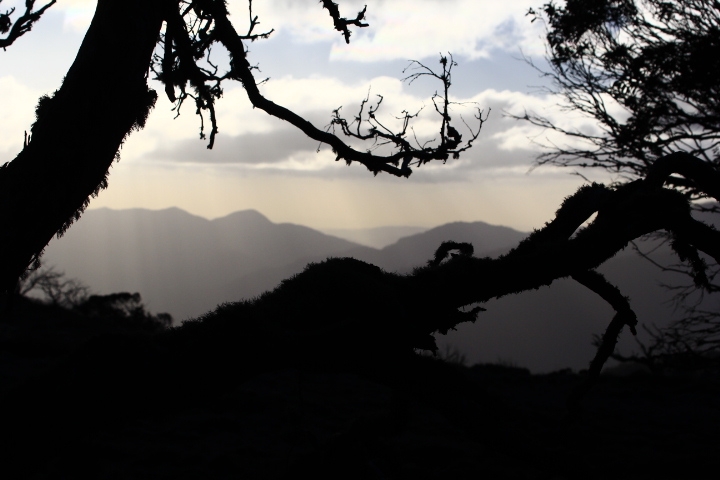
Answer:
[{"xmin": 396, "ymin": 154, "xmax": 720, "ymax": 406}]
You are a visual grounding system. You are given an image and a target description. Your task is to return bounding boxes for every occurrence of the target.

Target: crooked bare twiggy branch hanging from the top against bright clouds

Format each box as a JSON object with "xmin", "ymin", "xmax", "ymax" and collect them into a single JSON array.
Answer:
[{"xmin": 153, "ymin": 0, "xmax": 487, "ymax": 177}]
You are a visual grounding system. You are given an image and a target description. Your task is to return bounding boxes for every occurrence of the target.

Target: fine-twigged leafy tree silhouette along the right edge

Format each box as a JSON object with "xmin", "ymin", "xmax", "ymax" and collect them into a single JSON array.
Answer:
[{"xmin": 515, "ymin": 0, "xmax": 720, "ymax": 372}]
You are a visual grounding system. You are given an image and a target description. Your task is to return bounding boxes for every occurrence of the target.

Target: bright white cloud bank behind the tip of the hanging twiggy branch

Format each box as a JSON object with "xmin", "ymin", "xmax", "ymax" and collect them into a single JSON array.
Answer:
[{"xmin": 128, "ymin": 70, "xmax": 562, "ymax": 182}]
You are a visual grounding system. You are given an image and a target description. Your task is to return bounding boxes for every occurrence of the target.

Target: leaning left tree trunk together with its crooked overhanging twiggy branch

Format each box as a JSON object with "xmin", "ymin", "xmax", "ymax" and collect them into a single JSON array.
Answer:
[{"xmin": 0, "ymin": 0, "xmax": 483, "ymax": 291}]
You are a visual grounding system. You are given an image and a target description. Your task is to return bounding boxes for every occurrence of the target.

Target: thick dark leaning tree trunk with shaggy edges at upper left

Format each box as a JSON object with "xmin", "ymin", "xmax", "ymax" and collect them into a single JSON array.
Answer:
[{"xmin": 0, "ymin": 0, "xmax": 168, "ymax": 291}]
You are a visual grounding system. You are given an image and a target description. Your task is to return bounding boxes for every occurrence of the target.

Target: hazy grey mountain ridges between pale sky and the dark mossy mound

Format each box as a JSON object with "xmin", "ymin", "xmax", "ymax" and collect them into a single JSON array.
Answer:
[{"xmin": 43, "ymin": 208, "xmax": 525, "ymax": 319}]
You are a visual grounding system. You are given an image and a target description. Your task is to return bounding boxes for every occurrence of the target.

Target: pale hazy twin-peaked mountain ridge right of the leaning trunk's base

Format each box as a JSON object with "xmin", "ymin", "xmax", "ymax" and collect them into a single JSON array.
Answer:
[{"xmin": 43, "ymin": 208, "xmax": 358, "ymax": 319}]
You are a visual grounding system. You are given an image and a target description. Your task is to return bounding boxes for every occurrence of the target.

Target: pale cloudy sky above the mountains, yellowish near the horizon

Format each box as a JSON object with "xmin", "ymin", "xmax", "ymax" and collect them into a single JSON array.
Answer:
[{"xmin": 0, "ymin": 0, "xmax": 612, "ymax": 231}]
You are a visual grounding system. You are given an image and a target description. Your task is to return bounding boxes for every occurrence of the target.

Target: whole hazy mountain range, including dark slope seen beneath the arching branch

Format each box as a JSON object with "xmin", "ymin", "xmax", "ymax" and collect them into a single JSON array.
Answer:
[{"xmin": 38, "ymin": 208, "xmax": 704, "ymax": 372}]
